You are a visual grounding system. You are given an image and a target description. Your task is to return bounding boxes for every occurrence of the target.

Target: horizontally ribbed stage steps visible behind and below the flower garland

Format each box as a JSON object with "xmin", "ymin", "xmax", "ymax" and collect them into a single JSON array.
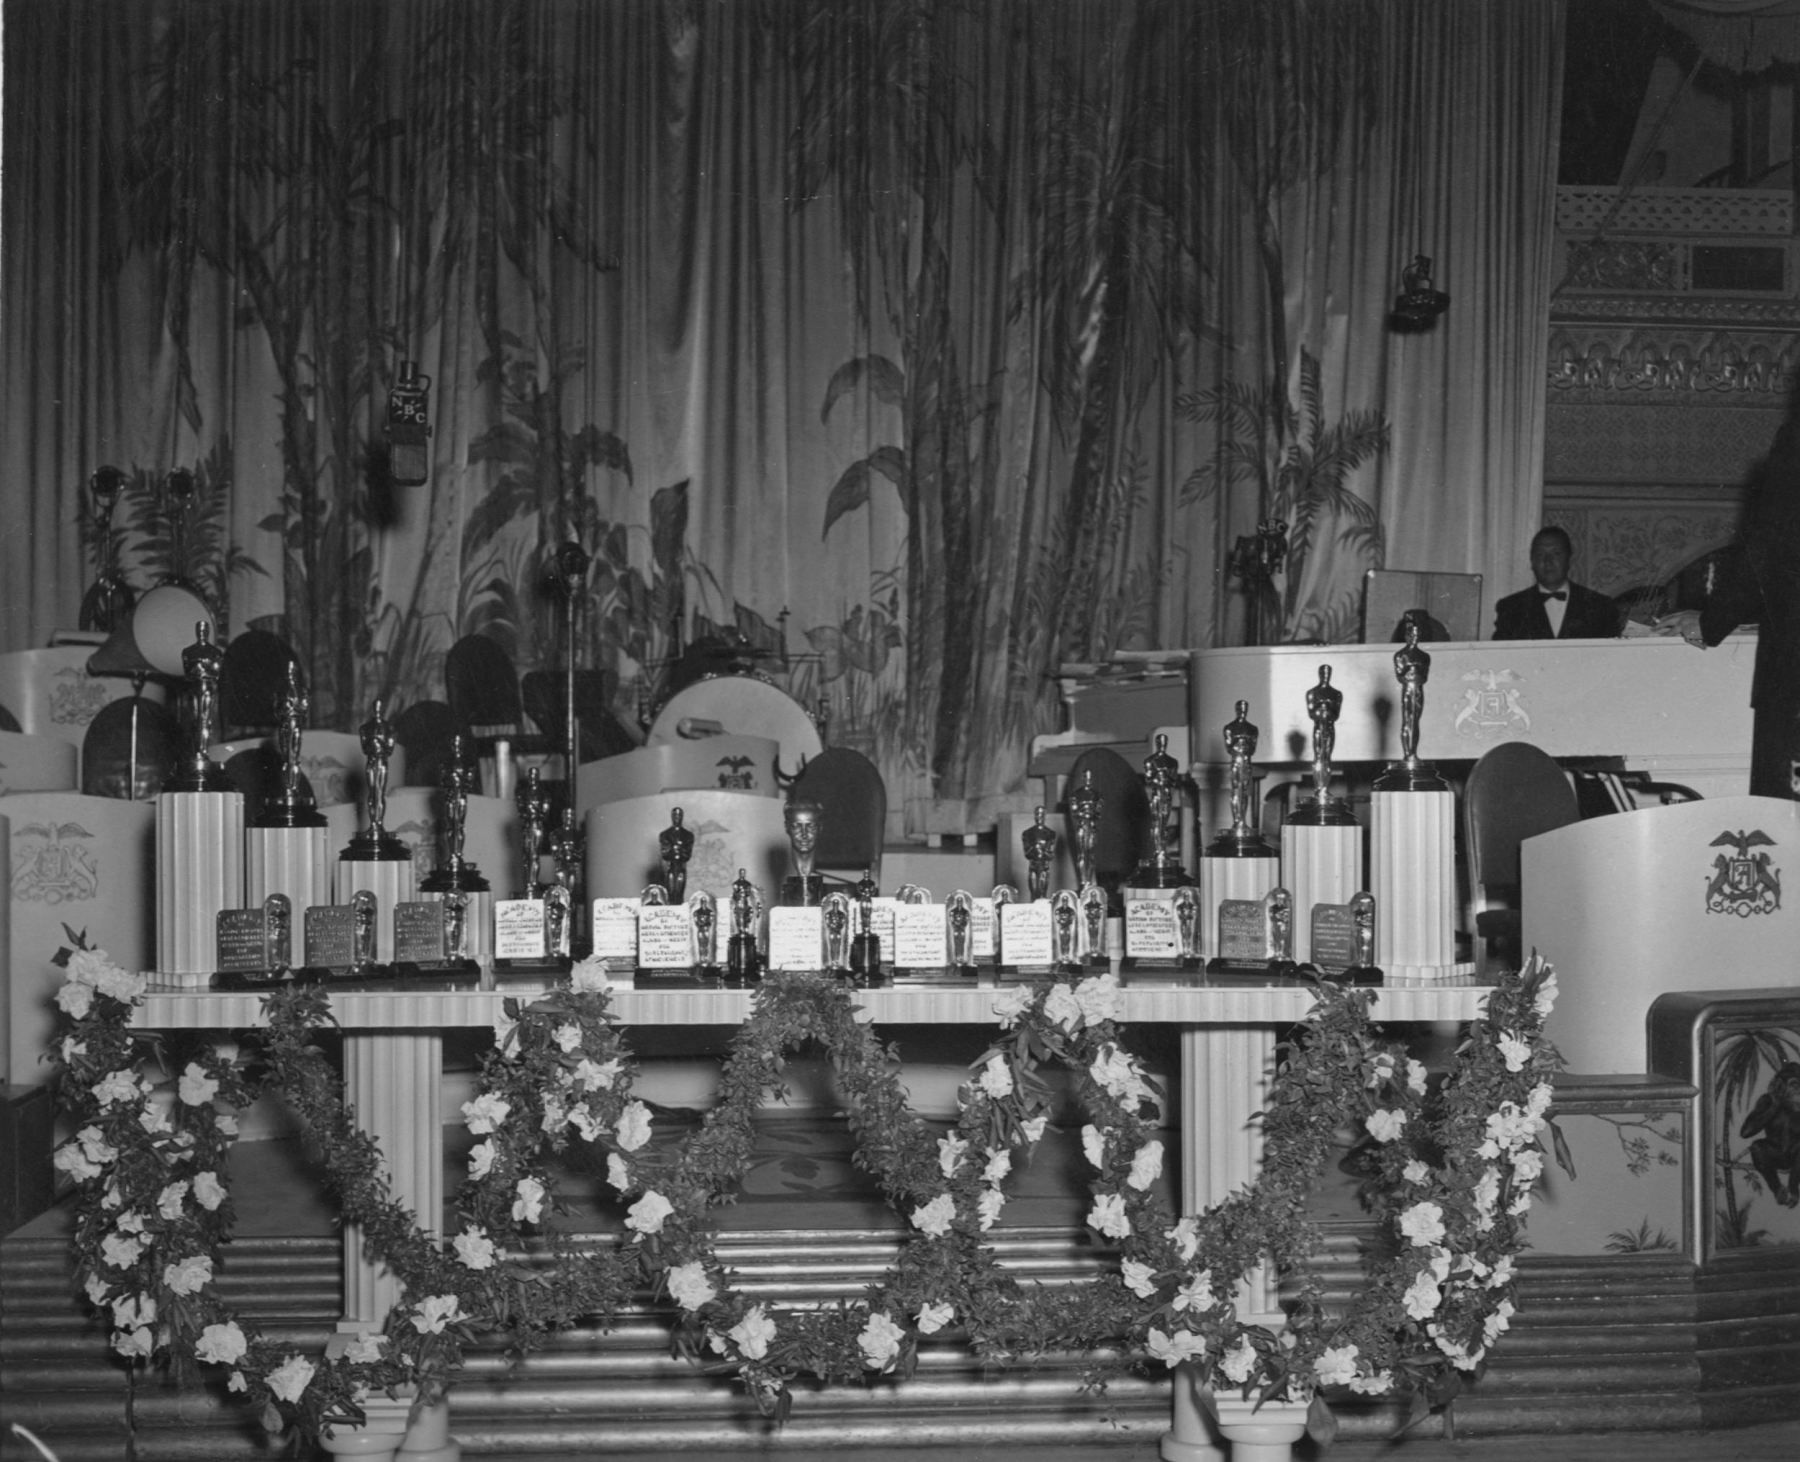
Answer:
[{"xmin": 0, "ymin": 1224, "xmax": 1780, "ymax": 1462}]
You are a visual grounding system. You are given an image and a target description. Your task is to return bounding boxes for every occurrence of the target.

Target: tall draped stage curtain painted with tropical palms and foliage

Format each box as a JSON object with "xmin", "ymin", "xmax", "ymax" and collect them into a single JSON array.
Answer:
[{"xmin": 0, "ymin": 0, "xmax": 1561, "ymax": 830}]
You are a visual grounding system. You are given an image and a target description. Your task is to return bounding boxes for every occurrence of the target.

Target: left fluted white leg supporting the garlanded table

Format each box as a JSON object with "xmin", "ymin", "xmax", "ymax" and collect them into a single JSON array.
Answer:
[{"xmin": 338, "ymin": 1030, "xmax": 445, "ymax": 1331}]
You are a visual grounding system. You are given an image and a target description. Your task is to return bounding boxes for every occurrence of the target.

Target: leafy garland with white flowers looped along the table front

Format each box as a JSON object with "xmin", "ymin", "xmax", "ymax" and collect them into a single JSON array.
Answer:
[{"xmin": 45, "ymin": 934, "xmax": 1561, "ymax": 1433}]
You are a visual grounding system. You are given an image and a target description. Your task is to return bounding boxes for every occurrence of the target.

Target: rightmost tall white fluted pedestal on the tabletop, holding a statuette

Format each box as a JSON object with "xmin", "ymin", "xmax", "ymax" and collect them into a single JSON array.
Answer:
[{"xmin": 1370, "ymin": 790, "xmax": 1474, "ymax": 979}]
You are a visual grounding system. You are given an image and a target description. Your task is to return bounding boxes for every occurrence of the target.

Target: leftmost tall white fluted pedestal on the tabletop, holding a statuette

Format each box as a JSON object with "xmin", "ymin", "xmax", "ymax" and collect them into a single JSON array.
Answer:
[{"xmin": 157, "ymin": 792, "xmax": 243, "ymax": 988}]
